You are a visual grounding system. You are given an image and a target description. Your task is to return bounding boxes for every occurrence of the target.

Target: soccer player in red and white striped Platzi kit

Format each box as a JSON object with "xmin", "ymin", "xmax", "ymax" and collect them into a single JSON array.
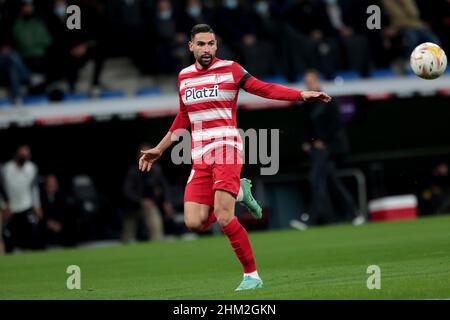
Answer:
[{"xmin": 139, "ymin": 24, "xmax": 331, "ymax": 291}]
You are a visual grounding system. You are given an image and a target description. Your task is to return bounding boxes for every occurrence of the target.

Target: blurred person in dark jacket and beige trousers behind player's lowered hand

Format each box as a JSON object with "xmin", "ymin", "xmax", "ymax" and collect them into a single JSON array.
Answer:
[{"xmin": 121, "ymin": 144, "xmax": 174, "ymax": 243}]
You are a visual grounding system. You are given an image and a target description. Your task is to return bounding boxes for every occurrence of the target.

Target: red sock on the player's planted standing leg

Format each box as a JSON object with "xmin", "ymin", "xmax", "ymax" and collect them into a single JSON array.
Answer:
[{"xmin": 222, "ymin": 217, "xmax": 256, "ymax": 273}]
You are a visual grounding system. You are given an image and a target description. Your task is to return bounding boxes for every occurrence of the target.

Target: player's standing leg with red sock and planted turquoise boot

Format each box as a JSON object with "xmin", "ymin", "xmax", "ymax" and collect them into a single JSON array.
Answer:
[{"xmin": 214, "ymin": 190, "xmax": 263, "ymax": 291}]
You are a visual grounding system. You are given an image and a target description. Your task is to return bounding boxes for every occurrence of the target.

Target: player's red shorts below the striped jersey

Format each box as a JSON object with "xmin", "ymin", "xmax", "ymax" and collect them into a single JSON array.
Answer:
[{"xmin": 184, "ymin": 163, "xmax": 242, "ymax": 207}]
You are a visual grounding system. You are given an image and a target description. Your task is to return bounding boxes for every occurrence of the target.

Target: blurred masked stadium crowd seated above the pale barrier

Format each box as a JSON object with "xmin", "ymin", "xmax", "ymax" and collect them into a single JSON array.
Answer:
[{"xmin": 0, "ymin": 0, "xmax": 450, "ymax": 102}]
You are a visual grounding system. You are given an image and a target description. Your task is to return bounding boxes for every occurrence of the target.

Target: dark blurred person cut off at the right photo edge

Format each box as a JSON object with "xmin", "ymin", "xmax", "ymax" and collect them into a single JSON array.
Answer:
[{"xmin": 419, "ymin": 163, "xmax": 450, "ymax": 215}]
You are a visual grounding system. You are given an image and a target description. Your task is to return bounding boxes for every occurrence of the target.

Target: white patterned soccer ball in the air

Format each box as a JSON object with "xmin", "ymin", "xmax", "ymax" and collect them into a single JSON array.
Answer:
[{"xmin": 410, "ymin": 42, "xmax": 447, "ymax": 80}]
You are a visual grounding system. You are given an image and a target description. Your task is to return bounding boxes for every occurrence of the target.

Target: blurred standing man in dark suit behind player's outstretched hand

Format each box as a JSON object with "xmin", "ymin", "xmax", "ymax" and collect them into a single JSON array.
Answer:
[{"xmin": 291, "ymin": 71, "xmax": 363, "ymax": 229}]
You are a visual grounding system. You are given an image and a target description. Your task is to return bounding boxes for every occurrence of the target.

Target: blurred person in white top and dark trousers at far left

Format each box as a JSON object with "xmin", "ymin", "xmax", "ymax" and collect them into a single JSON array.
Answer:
[{"xmin": 1, "ymin": 145, "xmax": 43, "ymax": 252}]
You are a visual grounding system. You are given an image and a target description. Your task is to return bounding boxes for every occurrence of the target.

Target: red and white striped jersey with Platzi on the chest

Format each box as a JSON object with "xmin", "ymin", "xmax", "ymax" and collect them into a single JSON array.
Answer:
[{"xmin": 170, "ymin": 58, "xmax": 301, "ymax": 161}]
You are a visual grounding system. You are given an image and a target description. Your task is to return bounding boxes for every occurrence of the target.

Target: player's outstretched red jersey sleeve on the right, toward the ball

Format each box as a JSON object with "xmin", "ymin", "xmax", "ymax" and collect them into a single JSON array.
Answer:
[{"xmin": 232, "ymin": 62, "xmax": 303, "ymax": 101}]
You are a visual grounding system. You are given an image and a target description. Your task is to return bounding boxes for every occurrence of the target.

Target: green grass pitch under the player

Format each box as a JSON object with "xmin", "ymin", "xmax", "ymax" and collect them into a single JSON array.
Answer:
[{"xmin": 0, "ymin": 216, "xmax": 450, "ymax": 299}]
